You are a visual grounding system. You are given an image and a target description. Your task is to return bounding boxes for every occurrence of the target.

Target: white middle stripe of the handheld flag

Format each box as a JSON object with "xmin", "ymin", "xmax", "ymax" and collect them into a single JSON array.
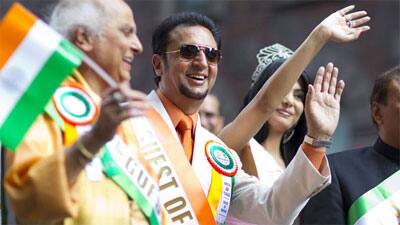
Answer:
[{"xmin": 0, "ymin": 20, "xmax": 61, "ymax": 128}]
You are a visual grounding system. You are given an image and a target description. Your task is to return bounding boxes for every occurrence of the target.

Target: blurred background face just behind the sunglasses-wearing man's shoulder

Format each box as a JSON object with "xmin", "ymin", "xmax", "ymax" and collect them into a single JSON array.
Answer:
[{"xmin": 199, "ymin": 94, "xmax": 224, "ymax": 134}]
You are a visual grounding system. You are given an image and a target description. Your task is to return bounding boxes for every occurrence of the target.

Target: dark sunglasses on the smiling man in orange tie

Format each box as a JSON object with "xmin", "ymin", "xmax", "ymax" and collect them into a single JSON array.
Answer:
[{"xmin": 164, "ymin": 45, "xmax": 222, "ymax": 64}]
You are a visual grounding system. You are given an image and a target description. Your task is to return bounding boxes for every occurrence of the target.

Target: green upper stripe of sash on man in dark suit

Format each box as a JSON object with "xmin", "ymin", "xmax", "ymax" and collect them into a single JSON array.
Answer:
[{"xmin": 348, "ymin": 171, "xmax": 400, "ymax": 225}]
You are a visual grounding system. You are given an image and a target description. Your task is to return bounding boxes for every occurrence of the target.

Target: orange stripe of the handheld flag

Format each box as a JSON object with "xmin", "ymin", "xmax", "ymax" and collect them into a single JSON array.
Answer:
[{"xmin": 0, "ymin": 4, "xmax": 36, "ymax": 70}]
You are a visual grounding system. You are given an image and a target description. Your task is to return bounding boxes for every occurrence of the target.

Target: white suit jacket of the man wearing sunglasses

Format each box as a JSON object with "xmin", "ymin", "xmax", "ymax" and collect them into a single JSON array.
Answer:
[{"xmin": 148, "ymin": 91, "xmax": 331, "ymax": 225}]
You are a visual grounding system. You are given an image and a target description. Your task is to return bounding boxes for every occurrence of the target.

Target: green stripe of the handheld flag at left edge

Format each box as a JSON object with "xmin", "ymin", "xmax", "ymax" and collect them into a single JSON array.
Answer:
[{"xmin": 0, "ymin": 40, "xmax": 83, "ymax": 151}]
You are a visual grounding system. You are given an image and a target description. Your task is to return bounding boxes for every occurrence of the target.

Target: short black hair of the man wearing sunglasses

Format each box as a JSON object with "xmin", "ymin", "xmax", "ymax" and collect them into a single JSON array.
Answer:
[{"xmin": 151, "ymin": 12, "xmax": 221, "ymax": 86}]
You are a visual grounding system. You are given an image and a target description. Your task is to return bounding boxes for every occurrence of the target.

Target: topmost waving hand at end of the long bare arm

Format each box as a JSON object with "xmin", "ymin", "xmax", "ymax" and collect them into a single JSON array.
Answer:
[{"xmin": 317, "ymin": 5, "xmax": 371, "ymax": 42}]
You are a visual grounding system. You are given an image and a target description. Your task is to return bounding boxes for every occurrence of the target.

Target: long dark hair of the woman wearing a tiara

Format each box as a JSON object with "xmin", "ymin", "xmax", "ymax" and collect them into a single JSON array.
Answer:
[{"xmin": 242, "ymin": 58, "xmax": 310, "ymax": 166}]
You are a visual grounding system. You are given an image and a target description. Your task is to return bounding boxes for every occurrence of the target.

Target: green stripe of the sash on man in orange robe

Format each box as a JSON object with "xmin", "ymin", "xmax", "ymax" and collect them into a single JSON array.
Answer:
[{"xmin": 101, "ymin": 146, "xmax": 160, "ymax": 225}]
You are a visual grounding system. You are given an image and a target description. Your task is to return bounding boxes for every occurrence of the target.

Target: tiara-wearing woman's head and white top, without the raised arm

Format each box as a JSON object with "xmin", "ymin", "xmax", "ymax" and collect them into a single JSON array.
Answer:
[{"xmin": 223, "ymin": 44, "xmax": 309, "ymax": 225}]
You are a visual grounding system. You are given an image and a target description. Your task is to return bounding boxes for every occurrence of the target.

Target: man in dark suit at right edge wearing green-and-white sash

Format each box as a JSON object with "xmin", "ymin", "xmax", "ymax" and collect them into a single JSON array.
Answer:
[{"xmin": 301, "ymin": 66, "xmax": 400, "ymax": 225}]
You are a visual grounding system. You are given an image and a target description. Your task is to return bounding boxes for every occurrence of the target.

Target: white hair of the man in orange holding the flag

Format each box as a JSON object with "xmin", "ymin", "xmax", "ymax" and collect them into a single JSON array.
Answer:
[{"xmin": 50, "ymin": 0, "xmax": 107, "ymax": 40}]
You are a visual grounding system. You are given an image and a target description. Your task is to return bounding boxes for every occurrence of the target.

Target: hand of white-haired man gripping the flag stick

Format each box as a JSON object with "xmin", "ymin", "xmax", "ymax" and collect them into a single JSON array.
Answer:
[{"xmin": 91, "ymin": 86, "xmax": 149, "ymax": 144}]
